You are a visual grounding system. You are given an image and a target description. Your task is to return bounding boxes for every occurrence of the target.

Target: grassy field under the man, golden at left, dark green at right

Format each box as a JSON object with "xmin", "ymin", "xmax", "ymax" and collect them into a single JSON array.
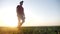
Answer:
[{"xmin": 0, "ymin": 26, "xmax": 60, "ymax": 34}]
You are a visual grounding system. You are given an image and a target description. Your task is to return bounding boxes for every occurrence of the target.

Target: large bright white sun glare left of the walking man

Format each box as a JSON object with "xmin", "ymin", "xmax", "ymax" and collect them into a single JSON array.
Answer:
[{"xmin": 0, "ymin": 7, "xmax": 18, "ymax": 27}]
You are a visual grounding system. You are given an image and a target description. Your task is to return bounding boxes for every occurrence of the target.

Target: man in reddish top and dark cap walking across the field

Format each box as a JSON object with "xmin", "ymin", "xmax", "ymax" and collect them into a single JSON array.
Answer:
[{"xmin": 17, "ymin": 1, "xmax": 25, "ymax": 26}]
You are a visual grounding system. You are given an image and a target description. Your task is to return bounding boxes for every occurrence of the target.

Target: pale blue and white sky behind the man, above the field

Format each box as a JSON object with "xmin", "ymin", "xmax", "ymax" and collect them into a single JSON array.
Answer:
[{"xmin": 0, "ymin": 0, "xmax": 60, "ymax": 26}]
